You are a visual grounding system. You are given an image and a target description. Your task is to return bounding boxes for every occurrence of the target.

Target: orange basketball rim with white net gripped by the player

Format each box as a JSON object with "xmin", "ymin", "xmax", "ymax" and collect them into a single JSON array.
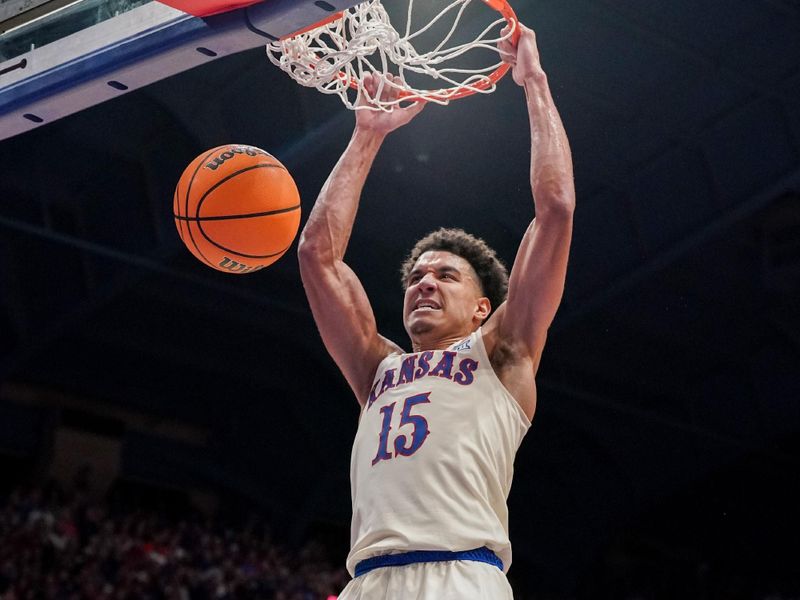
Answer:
[{"xmin": 267, "ymin": 0, "xmax": 519, "ymax": 111}]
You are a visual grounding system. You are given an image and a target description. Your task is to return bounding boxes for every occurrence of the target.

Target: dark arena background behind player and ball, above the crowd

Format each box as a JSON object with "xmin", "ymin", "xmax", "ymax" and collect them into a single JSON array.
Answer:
[{"xmin": 0, "ymin": 0, "xmax": 800, "ymax": 598}]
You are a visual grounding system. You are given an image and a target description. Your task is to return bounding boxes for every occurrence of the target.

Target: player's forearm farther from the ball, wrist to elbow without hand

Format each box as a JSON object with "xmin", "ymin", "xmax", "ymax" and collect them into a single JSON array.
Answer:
[{"xmin": 524, "ymin": 68, "xmax": 575, "ymax": 216}]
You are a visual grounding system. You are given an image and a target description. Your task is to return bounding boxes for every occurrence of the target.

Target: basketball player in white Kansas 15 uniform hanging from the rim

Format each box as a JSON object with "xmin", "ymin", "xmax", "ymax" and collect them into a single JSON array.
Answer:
[{"xmin": 299, "ymin": 22, "xmax": 575, "ymax": 600}]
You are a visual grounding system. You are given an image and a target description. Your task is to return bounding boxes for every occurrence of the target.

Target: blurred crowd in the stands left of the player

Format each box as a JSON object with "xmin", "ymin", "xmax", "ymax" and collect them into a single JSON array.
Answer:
[{"xmin": 0, "ymin": 484, "xmax": 349, "ymax": 600}]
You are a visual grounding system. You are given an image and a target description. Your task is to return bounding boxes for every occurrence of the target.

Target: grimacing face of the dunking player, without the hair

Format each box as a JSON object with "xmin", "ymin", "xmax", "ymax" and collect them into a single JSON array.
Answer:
[{"xmin": 403, "ymin": 250, "xmax": 488, "ymax": 336}]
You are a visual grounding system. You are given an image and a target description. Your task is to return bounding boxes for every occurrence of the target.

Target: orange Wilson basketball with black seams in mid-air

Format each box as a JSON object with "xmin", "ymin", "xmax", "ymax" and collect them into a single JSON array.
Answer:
[{"xmin": 173, "ymin": 144, "xmax": 300, "ymax": 274}]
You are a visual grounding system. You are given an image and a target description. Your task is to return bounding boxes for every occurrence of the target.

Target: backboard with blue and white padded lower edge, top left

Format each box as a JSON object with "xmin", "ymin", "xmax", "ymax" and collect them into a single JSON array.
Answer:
[{"xmin": 0, "ymin": 0, "xmax": 358, "ymax": 140}]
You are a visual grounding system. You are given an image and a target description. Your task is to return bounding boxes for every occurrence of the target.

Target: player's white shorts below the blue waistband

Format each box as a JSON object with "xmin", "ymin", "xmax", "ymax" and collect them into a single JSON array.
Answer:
[{"xmin": 339, "ymin": 560, "xmax": 514, "ymax": 600}]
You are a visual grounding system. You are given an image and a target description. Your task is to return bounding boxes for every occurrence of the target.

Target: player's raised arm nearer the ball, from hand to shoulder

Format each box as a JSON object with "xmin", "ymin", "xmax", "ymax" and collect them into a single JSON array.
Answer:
[{"xmin": 298, "ymin": 75, "xmax": 423, "ymax": 404}]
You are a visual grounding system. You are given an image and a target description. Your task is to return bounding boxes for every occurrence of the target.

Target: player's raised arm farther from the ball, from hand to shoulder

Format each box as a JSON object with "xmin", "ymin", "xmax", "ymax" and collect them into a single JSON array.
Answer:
[{"xmin": 493, "ymin": 24, "xmax": 575, "ymax": 372}]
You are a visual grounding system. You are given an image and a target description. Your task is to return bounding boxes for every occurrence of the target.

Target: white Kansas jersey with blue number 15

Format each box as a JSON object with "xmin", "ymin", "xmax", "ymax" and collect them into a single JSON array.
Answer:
[{"xmin": 347, "ymin": 329, "xmax": 530, "ymax": 575}]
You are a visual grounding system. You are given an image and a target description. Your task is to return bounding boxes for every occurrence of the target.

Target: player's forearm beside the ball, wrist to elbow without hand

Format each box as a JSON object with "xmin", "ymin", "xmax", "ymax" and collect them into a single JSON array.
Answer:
[{"xmin": 300, "ymin": 127, "xmax": 385, "ymax": 262}]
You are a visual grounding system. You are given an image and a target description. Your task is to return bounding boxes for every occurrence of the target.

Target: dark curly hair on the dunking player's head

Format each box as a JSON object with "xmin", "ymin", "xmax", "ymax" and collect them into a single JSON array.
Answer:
[{"xmin": 400, "ymin": 227, "xmax": 508, "ymax": 311}]
